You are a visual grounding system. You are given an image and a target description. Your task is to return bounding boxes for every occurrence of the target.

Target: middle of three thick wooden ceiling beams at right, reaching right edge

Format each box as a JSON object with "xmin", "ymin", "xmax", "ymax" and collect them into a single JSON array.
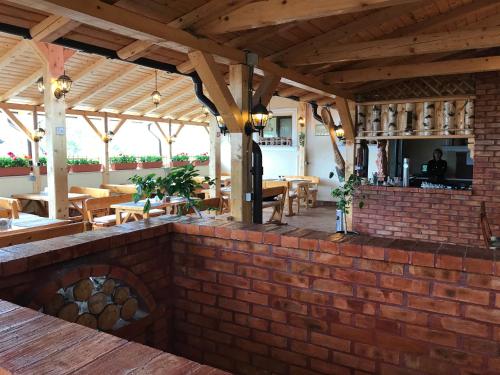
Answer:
[{"xmin": 287, "ymin": 26, "xmax": 500, "ymax": 65}]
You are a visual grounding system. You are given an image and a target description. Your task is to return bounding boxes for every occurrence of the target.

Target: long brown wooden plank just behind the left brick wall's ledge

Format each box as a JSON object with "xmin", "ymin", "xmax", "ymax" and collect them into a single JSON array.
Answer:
[{"xmin": 0, "ymin": 223, "xmax": 86, "ymax": 247}]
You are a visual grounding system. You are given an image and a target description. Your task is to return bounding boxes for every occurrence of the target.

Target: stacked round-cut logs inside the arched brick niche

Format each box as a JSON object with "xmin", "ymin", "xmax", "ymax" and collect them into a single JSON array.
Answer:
[{"xmin": 43, "ymin": 277, "xmax": 139, "ymax": 331}]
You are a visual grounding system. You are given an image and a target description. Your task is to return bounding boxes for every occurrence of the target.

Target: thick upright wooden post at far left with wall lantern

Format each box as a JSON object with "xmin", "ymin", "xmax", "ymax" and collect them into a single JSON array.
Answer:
[{"xmin": 37, "ymin": 43, "xmax": 68, "ymax": 219}]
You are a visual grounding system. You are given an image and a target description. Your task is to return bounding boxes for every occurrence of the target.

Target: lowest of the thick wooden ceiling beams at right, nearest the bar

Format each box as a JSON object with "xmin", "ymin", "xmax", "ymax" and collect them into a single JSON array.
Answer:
[{"xmin": 324, "ymin": 56, "xmax": 500, "ymax": 83}]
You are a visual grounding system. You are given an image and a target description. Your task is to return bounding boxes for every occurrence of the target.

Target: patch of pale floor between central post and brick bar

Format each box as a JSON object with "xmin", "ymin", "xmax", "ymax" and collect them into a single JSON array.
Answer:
[{"xmin": 264, "ymin": 206, "xmax": 336, "ymax": 232}]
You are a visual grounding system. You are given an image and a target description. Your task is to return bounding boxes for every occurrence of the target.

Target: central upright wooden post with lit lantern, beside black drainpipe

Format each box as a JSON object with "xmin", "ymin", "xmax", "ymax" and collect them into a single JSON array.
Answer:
[{"xmin": 229, "ymin": 64, "xmax": 252, "ymax": 223}]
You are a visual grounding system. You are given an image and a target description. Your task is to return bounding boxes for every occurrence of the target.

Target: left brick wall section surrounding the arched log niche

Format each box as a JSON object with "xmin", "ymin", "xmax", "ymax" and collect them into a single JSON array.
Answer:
[{"xmin": 0, "ymin": 220, "xmax": 172, "ymax": 350}]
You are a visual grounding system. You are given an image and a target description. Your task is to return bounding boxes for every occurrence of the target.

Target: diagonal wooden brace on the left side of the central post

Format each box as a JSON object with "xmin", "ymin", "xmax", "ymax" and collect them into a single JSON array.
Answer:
[{"xmin": 189, "ymin": 51, "xmax": 243, "ymax": 133}]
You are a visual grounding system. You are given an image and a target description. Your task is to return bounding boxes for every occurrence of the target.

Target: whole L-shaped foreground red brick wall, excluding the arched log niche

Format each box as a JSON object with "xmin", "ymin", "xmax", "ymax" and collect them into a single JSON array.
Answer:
[{"xmin": 0, "ymin": 217, "xmax": 500, "ymax": 375}]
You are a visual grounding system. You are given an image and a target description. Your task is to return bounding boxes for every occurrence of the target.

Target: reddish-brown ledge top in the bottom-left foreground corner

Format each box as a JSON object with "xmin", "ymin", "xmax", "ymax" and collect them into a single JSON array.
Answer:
[{"xmin": 0, "ymin": 300, "xmax": 226, "ymax": 375}]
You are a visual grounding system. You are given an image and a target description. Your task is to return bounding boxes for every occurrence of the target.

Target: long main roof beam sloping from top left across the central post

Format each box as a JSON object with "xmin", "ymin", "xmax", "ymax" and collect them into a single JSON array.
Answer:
[{"xmin": 16, "ymin": 0, "xmax": 344, "ymax": 97}]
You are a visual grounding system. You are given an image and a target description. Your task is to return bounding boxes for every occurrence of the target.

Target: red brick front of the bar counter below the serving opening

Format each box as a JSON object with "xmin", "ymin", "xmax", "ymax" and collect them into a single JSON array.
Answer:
[{"xmin": 353, "ymin": 186, "xmax": 481, "ymax": 246}]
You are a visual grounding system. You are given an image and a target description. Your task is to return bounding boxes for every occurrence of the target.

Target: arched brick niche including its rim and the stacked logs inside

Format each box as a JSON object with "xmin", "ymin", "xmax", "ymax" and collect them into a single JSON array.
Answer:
[{"xmin": 30, "ymin": 264, "xmax": 157, "ymax": 336}]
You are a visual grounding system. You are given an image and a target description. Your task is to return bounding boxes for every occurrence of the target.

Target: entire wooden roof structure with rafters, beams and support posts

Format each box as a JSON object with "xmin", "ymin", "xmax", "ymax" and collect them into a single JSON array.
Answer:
[{"xmin": 0, "ymin": 0, "xmax": 500, "ymax": 222}]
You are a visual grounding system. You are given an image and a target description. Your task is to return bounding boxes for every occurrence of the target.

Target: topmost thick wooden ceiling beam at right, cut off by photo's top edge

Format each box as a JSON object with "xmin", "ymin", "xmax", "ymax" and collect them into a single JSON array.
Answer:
[{"xmin": 200, "ymin": 0, "xmax": 418, "ymax": 34}]
